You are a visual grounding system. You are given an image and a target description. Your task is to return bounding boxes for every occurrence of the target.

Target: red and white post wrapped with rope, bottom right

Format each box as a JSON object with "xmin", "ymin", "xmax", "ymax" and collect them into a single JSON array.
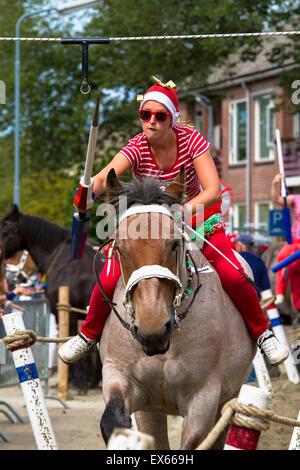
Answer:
[{"xmin": 224, "ymin": 385, "xmax": 273, "ymax": 450}]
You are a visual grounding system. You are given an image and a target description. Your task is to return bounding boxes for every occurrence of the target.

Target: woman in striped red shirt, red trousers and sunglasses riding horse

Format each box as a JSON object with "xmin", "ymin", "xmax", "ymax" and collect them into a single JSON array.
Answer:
[{"xmin": 58, "ymin": 77, "xmax": 289, "ymax": 365}]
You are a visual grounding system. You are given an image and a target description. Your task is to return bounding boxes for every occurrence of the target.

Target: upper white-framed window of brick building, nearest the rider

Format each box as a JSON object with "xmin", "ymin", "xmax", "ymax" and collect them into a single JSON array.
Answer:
[{"xmin": 229, "ymin": 101, "xmax": 247, "ymax": 164}]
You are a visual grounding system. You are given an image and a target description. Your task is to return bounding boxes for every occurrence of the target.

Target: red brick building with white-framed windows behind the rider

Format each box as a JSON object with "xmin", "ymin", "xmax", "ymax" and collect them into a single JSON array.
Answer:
[{"xmin": 179, "ymin": 41, "xmax": 300, "ymax": 241}]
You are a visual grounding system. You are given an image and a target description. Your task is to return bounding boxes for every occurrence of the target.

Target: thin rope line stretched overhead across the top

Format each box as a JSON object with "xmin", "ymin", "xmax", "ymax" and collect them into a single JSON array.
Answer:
[{"xmin": 0, "ymin": 31, "xmax": 300, "ymax": 42}]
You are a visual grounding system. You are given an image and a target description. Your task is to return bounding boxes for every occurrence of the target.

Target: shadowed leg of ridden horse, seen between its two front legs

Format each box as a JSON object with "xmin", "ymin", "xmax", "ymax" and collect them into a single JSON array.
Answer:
[{"xmin": 134, "ymin": 411, "xmax": 170, "ymax": 450}]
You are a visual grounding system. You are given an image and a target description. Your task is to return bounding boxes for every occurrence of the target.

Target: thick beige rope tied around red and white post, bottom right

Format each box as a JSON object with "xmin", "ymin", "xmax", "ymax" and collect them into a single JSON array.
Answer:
[{"xmin": 196, "ymin": 398, "xmax": 300, "ymax": 450}]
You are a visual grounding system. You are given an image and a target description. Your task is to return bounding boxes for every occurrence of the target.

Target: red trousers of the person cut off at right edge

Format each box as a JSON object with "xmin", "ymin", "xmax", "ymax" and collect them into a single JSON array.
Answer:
[{"xmin": 275, "ymin": 239, "xmax": 300, "ymax": 309}]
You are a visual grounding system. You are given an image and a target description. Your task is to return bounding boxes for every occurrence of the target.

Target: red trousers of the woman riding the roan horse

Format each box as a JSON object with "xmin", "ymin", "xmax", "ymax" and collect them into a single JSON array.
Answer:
[{"xmin": 81, "ymin": 231, "xmax": 268, "ymax": 339}]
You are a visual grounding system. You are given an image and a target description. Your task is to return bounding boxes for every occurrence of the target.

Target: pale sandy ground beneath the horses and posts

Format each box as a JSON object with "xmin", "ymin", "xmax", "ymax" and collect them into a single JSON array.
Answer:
[{"xmin": 0, "ymin": 324, "xmax": 300, "ymax": 451}]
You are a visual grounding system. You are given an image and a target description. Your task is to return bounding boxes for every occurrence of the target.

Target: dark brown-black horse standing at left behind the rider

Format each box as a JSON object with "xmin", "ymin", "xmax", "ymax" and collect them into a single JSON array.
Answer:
[{"xmin": 0, "ymin": 204, "xmax": 104, "ymax": 394}]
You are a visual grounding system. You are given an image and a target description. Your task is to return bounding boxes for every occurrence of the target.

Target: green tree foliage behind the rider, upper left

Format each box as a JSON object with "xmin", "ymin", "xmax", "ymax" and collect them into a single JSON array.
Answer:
[{"xmin": 0, "ymin": 0, "xmax": 288, "ymax": 232}]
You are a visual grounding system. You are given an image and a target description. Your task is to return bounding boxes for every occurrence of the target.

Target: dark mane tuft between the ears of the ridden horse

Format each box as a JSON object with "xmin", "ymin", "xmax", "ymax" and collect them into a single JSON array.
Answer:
[{"xmin": 110, "ymin": 178, "xmax": 180, "ymax": 208}]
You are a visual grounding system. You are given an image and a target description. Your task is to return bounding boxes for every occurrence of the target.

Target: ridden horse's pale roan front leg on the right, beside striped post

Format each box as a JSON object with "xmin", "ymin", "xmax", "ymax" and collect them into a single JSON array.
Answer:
[{"xmin": 180, "ymin": 380, "xmax": 220, "ymax": 450}]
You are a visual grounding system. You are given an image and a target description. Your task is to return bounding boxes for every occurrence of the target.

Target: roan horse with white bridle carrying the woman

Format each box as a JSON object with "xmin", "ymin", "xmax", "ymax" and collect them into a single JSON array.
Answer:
[{"xmin": 99, "ymin": 169, "xmax": 256, "ymax": 450}]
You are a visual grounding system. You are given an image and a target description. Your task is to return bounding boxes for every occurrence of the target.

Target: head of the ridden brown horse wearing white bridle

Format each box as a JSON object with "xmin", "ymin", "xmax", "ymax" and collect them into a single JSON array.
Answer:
[{"xmin": 107, "ymin": 170, "xmax": 184, "ymax": 356}]
